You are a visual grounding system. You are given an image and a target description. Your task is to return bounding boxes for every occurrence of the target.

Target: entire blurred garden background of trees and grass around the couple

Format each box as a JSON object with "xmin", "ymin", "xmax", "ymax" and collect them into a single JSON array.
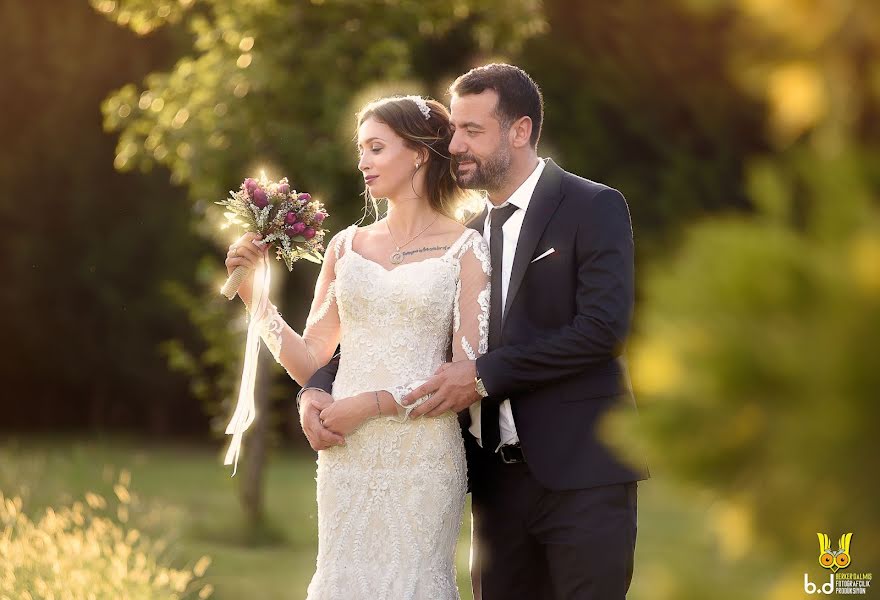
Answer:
[{"xmin": 0, "ymin": 0, "xmax": 880, "ymax": 600}]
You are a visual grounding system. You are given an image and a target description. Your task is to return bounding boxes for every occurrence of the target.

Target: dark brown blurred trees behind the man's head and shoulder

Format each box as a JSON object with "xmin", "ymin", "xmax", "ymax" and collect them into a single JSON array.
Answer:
[{"xmin": 517, "ymin": 0, "xmax": 768, "ymax": 255}]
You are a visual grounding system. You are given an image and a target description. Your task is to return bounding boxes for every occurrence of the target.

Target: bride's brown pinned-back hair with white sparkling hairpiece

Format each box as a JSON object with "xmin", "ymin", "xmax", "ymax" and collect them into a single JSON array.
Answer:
[{"xmin": 357, "ymin": 96, "xmax": 477, "ymax": 221}]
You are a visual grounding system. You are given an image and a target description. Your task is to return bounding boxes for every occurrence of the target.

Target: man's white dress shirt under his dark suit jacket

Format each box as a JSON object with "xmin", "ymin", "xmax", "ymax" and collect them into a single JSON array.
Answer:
[{"xmin": 469, "ymin": 158, "xmax": 545, "ymax": 451}]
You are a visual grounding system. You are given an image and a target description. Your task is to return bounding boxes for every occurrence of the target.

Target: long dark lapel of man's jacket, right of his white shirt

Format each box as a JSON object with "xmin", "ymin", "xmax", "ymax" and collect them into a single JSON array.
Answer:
[{"xmin": 502, "ymin": 160, "xmax": 562, "ymax": 328}]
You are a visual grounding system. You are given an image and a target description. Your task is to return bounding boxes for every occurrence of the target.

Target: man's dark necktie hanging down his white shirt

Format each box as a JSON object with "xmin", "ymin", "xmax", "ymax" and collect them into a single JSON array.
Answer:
[{"xmin": 480, "ymin": 204, "xmax": 517, "ymax": 452}]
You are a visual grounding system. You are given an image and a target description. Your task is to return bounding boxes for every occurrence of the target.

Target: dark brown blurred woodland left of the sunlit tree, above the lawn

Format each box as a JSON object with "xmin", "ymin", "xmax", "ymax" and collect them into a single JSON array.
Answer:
[{"xmin": 0, "ymin": 0, "xmax": 206, "ymax": 435}]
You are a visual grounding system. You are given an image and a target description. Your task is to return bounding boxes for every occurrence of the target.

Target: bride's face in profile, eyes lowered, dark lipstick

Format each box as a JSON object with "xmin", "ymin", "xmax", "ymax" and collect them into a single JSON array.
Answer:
[{"xmin": 358, "ymin": 117, "xmax": 418, "ymax": 199}]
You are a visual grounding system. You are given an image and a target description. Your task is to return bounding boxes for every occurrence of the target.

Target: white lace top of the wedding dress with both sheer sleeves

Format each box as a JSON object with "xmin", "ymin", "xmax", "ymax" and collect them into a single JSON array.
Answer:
[{"xmin": 254, "ymin": 225, "xmax": 490, "ymax": 413}]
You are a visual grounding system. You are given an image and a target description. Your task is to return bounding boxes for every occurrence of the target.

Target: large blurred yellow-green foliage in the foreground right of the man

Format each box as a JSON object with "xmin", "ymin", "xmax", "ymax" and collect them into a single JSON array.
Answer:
[{"xmin": 608, "ymin": 1, "xmax": 880, "ymax": 598}]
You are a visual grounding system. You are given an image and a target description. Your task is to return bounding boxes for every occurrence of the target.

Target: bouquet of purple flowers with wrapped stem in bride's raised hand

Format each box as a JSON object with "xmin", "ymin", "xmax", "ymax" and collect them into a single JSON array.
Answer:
[{"xmin": 214, "ymin": 174, "xmax": 327, "ymax": 300}]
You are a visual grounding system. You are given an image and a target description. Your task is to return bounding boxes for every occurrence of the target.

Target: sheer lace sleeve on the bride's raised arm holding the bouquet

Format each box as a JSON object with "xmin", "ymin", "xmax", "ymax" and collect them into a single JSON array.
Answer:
[{"xmin": 251, "ymin": 231, "xmax": 348, "ymax": 385}]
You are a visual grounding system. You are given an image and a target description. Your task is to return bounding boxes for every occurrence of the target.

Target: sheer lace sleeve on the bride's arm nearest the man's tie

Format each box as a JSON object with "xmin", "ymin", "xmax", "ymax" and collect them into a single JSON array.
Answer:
[{"xmin": 386, "ymin": 232, "xmax": 491, "ymax": 421}]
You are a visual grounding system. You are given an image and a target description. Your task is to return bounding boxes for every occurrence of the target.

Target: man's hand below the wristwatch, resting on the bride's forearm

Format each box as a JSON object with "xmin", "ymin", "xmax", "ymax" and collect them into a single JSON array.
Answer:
[{"xmin": 401, "ymin": 360, "xmax": 480, "ymax": 418}]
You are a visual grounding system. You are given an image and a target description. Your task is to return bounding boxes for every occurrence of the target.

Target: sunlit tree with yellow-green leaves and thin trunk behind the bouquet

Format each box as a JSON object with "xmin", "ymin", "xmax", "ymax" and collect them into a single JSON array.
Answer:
[{"xmin": 98, "ymin": 0, "xmax": 543, "ymax": 522}]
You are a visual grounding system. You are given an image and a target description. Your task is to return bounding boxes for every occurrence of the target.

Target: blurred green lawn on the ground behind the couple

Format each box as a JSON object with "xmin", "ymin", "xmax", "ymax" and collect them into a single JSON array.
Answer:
[{"xmin": 0, "ymin": 437, "xmax": 768, "ymax": 600}]
